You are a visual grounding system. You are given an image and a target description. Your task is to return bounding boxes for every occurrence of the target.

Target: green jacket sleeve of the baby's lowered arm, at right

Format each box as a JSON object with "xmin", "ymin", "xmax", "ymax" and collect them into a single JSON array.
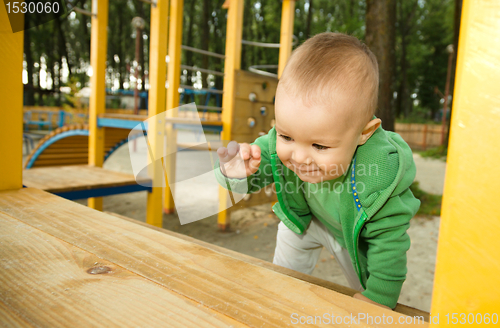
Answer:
[{"xmin": 361, "ymin": 188, "xmax": 420, "ymax": 308}]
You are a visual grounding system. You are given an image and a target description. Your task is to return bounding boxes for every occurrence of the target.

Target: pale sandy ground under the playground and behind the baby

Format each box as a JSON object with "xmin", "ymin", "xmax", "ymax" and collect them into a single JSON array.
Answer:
[{"xmin": 25, "ymin": 133, "xmax": 446, "ymax": 311}]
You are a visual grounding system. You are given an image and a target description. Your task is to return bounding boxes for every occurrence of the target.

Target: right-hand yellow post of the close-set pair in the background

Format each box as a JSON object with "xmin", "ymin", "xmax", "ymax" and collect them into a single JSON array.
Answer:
[{"xmin": 164, "ymin": 0, "xmax": 184, "ymax": 213}]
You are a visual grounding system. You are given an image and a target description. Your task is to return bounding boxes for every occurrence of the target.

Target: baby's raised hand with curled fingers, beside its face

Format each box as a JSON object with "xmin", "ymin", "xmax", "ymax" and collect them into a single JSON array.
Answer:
[{"xmin": 217, "ymin": 141, "xmax": 261, "ymax": 179}]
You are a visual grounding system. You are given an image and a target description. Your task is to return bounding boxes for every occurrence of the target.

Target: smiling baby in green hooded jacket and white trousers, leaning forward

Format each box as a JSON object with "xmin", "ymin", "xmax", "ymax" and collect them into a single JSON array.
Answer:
[{"xmin": 215, "ymin": 33, "xmax": 420, "ymax": 308}]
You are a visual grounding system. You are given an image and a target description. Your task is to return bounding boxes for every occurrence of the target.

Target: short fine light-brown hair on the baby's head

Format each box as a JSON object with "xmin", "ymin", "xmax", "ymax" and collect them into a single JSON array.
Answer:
[{"xmin": 279, "ymin": 32, "xmax": 379, "ymax": 127}]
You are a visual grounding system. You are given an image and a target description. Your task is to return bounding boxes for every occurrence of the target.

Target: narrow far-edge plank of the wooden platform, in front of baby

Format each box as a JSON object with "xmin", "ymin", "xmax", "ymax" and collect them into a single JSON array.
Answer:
[{"xmin": 105, "ymin": 212, "xmax": 429, "ymax": 322}]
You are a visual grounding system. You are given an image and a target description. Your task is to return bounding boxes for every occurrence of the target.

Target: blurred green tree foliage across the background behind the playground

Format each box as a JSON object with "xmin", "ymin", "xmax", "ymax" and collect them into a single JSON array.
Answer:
[{"xmin": 25, "ymin": 0, "xmax": 454, "ymax": 122}]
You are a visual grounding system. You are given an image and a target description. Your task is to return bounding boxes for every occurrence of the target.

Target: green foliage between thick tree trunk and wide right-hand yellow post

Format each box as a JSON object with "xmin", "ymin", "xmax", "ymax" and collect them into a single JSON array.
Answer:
[{"xmin": 394, "ymin": 0, "xmax": 454, "ymax": 123}]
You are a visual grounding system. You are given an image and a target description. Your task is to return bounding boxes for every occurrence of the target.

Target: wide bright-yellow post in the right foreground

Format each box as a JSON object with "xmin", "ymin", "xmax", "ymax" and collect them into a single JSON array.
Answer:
[{"xmin": 431, "ymin": 0, "xmax": 500, "ymax": 327}]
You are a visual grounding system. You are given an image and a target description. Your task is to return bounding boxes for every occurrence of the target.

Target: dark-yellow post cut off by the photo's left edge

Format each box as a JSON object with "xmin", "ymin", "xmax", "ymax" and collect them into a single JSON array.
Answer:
[{"xmin": 0, "ymin": 5, "xmax": 24, "ymax": 190}]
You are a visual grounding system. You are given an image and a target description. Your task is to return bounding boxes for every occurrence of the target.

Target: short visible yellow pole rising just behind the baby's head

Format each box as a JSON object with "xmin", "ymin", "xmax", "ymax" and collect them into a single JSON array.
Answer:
[{"xmin": 278, "ymin": 0, "xmax": 295, "ymax": 79}]
